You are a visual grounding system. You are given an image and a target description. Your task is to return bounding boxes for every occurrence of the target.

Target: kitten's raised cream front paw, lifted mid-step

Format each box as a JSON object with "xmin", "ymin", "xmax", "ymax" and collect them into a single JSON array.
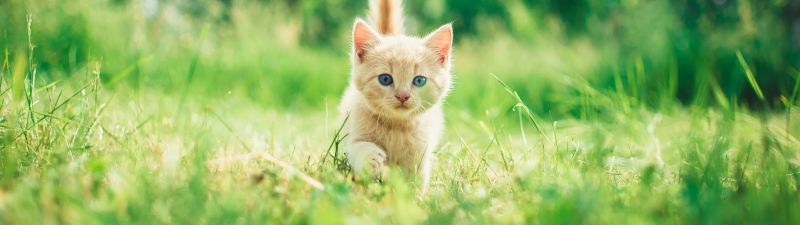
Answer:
[{"xmin": 345, "ymin": 141, "xmax": 386, "ymax": 177}]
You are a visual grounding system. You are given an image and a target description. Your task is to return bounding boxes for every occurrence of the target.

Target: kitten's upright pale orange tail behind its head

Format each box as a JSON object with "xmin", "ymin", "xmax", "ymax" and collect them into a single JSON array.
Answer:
[{"xmin": 369, "ymin": 0, "xmax": 404, "ymax": 35}]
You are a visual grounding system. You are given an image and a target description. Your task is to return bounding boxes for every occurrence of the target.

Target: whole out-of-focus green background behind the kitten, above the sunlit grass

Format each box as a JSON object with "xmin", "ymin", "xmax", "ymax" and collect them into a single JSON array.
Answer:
[{"xmin": 0, "ymin": 0, "xmax": 800, "ymax": 113}]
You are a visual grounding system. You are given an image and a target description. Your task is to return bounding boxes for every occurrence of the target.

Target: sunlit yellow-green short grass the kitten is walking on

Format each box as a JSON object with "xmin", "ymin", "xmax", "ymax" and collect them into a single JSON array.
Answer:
[{"xmin": 0, "ymin": 55, "xmax": 800, "ymax": 224}]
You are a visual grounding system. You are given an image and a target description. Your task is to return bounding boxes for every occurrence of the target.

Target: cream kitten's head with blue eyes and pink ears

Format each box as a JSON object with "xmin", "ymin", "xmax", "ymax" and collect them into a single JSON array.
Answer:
[{"xmin": 350, "ymin": 20, "xmax": 453, "ymax": 118}]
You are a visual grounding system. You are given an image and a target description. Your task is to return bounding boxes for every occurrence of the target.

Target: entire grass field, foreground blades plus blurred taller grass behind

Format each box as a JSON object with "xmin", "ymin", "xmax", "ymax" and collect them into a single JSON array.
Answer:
[{"xmin": 0, "ymin": 0, "xmax": 800, "ymax": 224}]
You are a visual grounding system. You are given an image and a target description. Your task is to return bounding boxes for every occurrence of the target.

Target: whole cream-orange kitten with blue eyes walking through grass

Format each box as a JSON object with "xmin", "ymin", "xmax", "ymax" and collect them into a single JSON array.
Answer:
[{"xmin": 339, "ymin": 0, "xmax": 453, "ymax": 193}]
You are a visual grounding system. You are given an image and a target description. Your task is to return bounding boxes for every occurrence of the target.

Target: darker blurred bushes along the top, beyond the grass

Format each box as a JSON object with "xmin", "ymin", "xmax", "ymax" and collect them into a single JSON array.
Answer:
[{"xmin": 0, "ymin": 0, "xmax": 800, "ymax": 107}]
